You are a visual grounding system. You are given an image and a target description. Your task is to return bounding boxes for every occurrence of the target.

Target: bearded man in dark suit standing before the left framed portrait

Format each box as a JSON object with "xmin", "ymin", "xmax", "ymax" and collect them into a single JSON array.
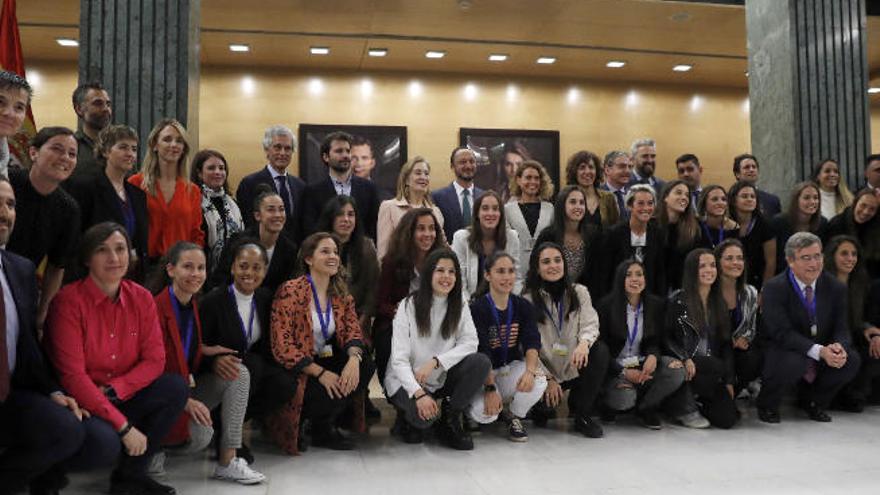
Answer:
[{"xmin": 298, "ymin": 131, "xmax": 379, "ymax": 242}]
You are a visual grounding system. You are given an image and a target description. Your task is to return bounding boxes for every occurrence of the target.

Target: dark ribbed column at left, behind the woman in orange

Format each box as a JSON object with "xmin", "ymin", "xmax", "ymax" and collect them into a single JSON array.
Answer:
[{"xmin": 79, "ymin": 0, "xmax": 201, "ymax": 155}]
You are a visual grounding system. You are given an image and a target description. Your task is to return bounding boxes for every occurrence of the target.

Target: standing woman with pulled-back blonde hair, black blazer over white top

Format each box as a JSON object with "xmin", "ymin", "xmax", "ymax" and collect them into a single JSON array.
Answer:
[{"xmin": 603, "ymin": 184, "xmax": 668, "ymax": 297}]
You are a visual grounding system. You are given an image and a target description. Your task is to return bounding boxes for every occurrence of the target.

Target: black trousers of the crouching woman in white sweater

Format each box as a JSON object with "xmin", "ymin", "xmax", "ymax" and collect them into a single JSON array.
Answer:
[{"xmin": 388, "ymin": 352, "xmax": 492, "ymax": 430}]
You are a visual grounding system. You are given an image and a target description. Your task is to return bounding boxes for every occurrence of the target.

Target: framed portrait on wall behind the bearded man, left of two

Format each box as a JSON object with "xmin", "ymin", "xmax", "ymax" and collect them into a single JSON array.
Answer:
[{"xmin": 299, "ymin": 124, "xmax": 408, "ymax": 199}]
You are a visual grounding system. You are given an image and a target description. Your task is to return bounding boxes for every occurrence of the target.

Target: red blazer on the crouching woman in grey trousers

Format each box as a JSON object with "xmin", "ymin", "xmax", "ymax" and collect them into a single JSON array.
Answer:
[{"xmin": 153, "ymin": 287, "xmax": 202, "ymax": 445}]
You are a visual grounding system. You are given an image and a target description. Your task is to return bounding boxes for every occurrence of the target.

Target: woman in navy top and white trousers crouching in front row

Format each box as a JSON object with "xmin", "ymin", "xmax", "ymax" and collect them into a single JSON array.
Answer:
[{"xmin": 470, "ymin": 251, "xmax": 547, "ymax": 442}]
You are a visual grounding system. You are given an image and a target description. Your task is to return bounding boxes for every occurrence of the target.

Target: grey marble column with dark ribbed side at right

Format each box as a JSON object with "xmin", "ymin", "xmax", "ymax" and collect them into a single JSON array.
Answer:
[{"xmin": 746, "ymin": 0, "xmax": 871, "ymax": 194}]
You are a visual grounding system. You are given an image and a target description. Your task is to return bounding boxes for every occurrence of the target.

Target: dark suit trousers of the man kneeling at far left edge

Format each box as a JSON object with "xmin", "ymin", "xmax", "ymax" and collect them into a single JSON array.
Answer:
[{"xmin": 0, "ymin": 390, "xmax": 85, "ymax": 493}]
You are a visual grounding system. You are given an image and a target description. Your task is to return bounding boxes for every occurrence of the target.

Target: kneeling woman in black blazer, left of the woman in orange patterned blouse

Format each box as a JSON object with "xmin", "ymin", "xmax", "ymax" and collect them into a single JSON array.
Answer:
[{"xmin": 199, "ymin": 239, "xmax": 296, "ymax": 430}]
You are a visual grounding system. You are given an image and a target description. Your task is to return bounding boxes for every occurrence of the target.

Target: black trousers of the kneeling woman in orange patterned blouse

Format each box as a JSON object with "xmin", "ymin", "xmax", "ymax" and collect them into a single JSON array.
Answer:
[{"xmin": 302, "ymin": 346, "xmax": 376, "ymax": 425}]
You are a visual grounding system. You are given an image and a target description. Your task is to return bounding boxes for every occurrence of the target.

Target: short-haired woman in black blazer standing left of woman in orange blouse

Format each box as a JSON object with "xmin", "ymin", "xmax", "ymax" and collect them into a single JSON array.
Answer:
[{"xmin": 68, "ymin": 125, "xmax": 149, "ymax": 283}]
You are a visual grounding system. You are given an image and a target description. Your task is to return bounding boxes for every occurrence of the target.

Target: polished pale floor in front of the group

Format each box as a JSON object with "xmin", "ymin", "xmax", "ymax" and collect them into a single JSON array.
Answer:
[{"xmin": 64, "ymin": 401, "xmax": 880, "ymax": 495}]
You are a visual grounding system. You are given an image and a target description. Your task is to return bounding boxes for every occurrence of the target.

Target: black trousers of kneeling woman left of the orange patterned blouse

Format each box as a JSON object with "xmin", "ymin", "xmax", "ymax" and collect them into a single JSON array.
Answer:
[{"xmin": 242, "ymin": 352, "xmax": 297, "ymax": 420}]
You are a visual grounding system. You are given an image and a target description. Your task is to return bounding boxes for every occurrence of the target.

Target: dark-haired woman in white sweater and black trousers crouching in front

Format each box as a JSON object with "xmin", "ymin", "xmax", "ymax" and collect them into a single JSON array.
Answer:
[{"xmin": 385, "ymin": 248, "xmax": 491, "ymax": 450}]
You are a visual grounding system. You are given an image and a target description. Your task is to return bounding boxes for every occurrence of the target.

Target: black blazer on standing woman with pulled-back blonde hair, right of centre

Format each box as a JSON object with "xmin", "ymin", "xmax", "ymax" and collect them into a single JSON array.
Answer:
[{"xmin": 600, "ymin": 220, "xmax": 668, "ymax": 297}]
